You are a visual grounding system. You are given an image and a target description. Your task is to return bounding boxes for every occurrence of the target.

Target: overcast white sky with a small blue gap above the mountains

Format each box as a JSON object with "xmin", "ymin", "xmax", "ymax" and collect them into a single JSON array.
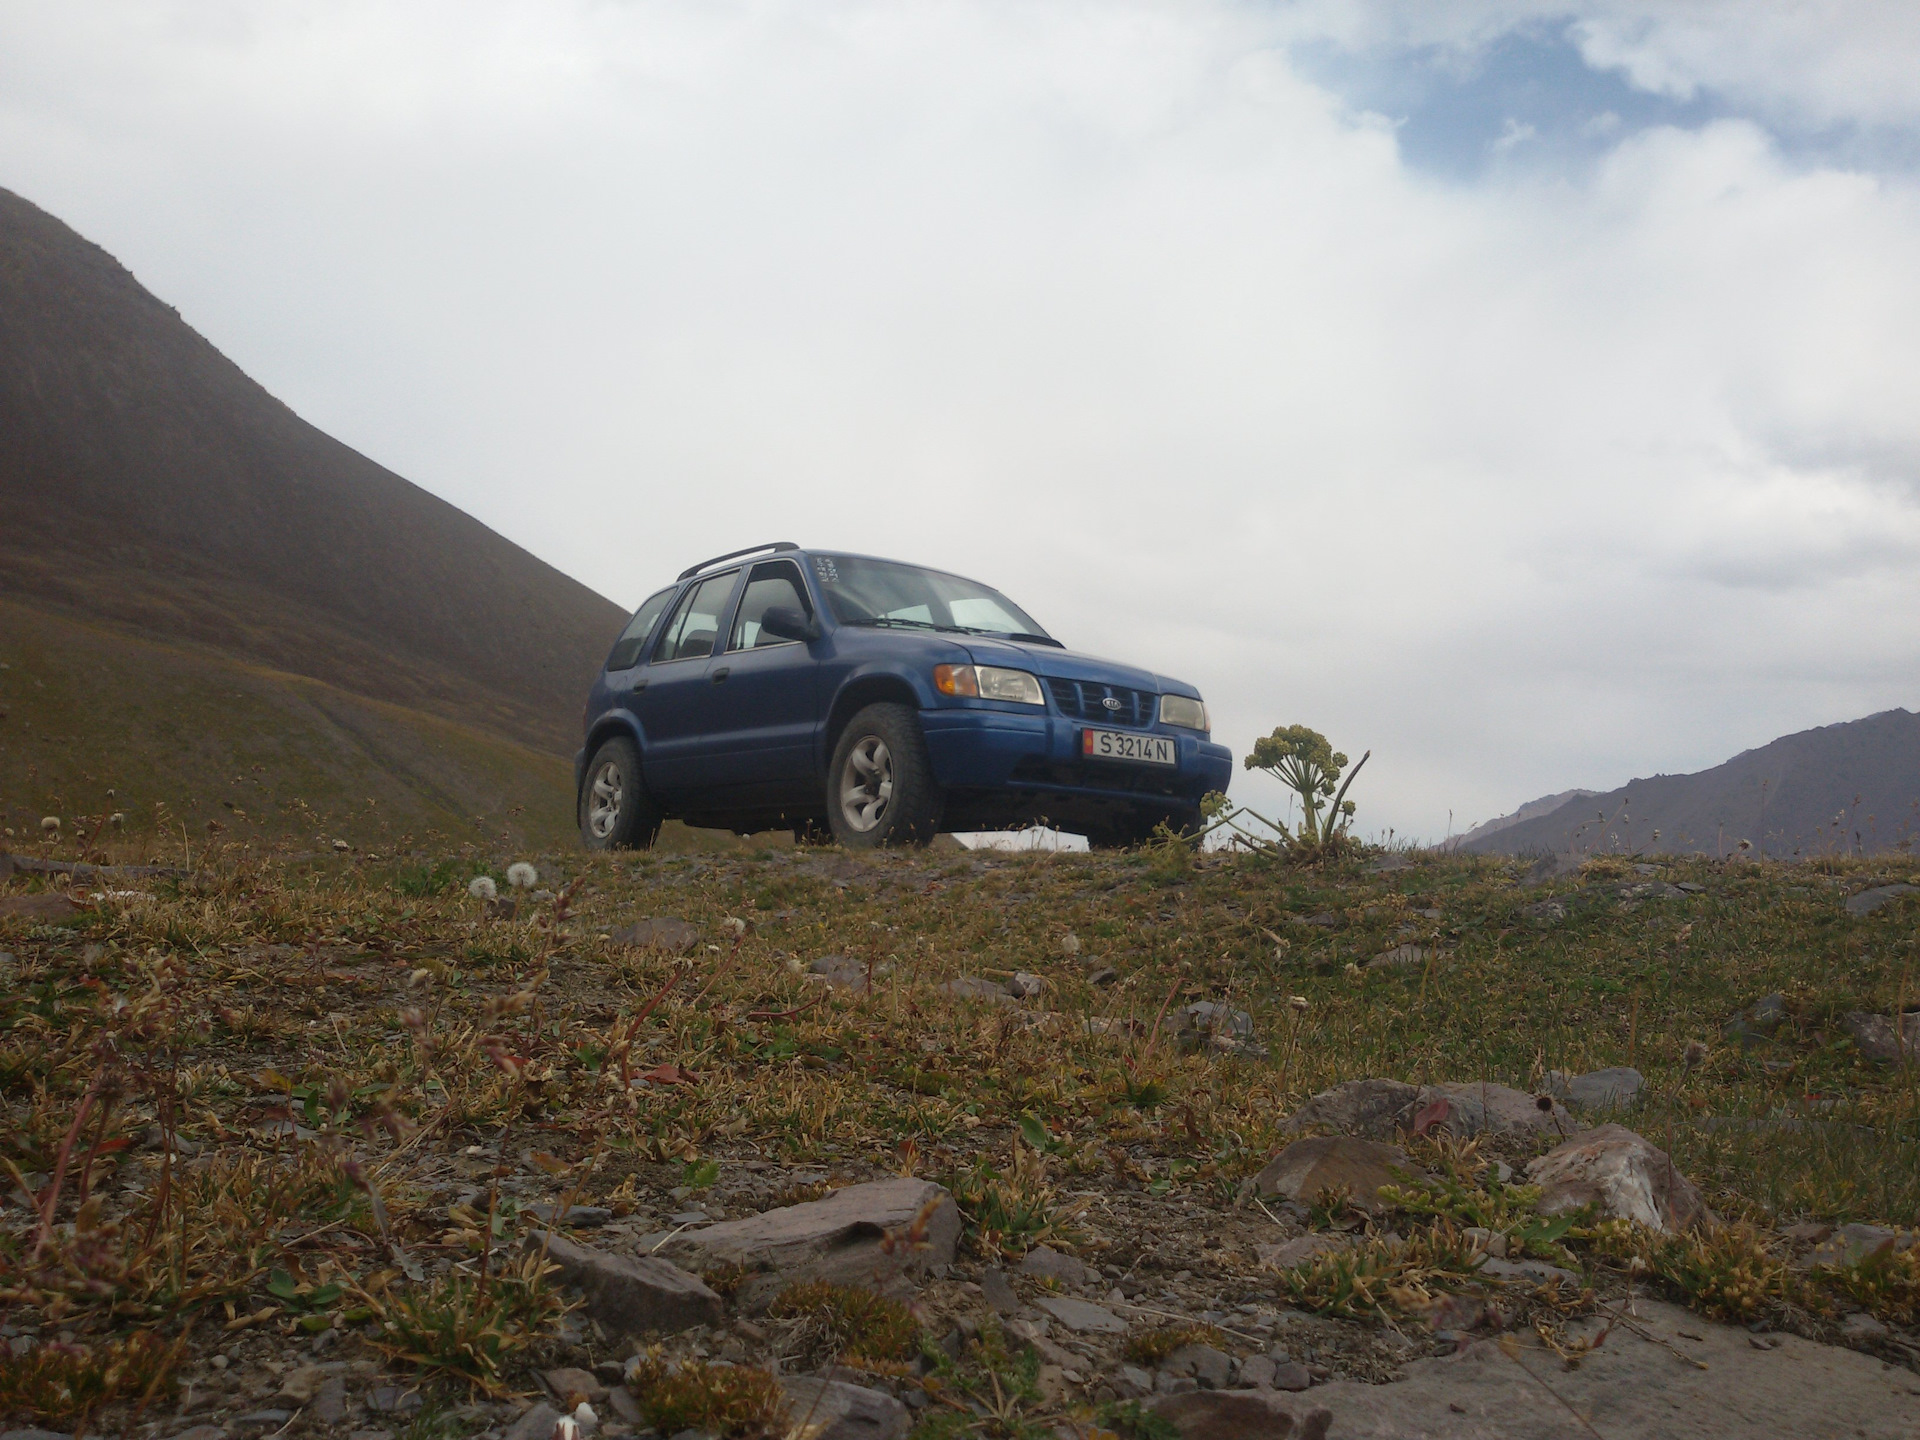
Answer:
[{"xmin": 0, "ymin": 0, "xmax": 1920, "ymax": 839}]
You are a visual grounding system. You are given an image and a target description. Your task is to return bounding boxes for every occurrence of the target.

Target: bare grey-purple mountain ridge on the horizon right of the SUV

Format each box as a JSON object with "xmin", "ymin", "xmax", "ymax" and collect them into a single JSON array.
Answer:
[{"xmin": 1457, "ymin": 710, "xmax": 1920, "ymax": 860}]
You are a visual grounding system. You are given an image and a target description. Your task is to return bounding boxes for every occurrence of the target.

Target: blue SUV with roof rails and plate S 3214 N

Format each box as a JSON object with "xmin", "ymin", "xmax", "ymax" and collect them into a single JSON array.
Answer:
[{"xmin": 574, "ymin": 541, "xmax": 1233, "ymax": 851}]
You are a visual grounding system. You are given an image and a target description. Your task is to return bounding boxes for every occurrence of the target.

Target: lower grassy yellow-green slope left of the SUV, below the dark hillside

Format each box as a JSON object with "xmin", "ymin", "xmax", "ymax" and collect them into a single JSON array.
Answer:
[{"xmin": 0, "ymin": 599, "xmax": 572, "ymax": 849}]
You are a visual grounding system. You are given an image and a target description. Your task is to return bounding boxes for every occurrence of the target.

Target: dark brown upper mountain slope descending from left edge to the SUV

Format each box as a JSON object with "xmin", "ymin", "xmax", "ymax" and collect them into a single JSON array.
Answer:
[{"xmin": 0, "ymin": 190, "xmax": 624, "ymax": 753}]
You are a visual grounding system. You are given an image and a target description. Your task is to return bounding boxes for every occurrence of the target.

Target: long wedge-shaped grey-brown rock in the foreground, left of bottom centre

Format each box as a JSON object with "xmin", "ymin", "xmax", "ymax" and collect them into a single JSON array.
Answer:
[{"xmin": 662, "ymin": 1179, "xmax": 960, "ymax": 1311}]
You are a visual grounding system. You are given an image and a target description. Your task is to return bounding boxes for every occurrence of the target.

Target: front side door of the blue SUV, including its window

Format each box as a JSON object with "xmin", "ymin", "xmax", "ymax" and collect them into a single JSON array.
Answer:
[{"xmin": 703, "ymin": 561, "xmax": 820, "ymax": 804}]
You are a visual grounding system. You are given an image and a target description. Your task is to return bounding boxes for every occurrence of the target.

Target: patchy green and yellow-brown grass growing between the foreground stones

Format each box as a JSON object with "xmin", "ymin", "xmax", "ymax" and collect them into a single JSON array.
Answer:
[{"xmin": 0, "ymin": 835, "xmax": 1920, "ymax": 1434}]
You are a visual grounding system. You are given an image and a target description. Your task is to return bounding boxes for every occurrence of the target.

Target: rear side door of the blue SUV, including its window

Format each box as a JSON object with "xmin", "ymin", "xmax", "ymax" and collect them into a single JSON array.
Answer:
[{"xmin": 634, "ymin": 570, "xmax": 739, "ymax": 799}]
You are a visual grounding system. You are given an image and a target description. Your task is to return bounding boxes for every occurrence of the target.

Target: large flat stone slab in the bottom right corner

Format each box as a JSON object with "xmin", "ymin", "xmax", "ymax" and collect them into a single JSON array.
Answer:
[{"xmin": 1311, "ymin": 1296, "xmax": 1920, "ymax": 1440}]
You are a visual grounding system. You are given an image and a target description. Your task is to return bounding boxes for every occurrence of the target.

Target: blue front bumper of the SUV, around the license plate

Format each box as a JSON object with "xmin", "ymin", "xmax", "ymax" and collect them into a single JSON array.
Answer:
[{"xmin": 920, "ymin": 707, "xmax": 1233, "ymax": 808}]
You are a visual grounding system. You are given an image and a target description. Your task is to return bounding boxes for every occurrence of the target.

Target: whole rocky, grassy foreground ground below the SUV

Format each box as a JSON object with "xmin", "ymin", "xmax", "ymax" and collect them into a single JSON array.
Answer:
[{"xmin": 0, "ymin": 851, "xmax": 1920, "ymax": 1440}]
